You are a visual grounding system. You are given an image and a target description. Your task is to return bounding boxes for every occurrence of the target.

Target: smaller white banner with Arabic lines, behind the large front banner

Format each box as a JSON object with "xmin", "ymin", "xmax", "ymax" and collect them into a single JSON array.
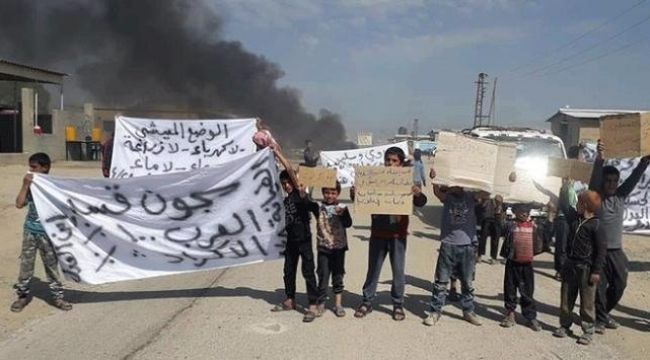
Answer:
[{"xmin": 111, "ymin": 116, "xmax": 256, "ymax": 178}]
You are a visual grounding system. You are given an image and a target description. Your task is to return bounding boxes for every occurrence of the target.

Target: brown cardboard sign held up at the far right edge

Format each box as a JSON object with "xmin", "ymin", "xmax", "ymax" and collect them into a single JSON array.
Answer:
[{"xmin": 600, "ymin": 113, "xmax": 650, "ymax": 158}]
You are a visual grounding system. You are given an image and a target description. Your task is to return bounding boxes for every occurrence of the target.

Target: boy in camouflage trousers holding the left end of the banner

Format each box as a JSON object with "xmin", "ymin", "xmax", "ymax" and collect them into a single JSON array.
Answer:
[{"xmin": 11, "ymin": 153, "xmax": 72, "ymax": 312}]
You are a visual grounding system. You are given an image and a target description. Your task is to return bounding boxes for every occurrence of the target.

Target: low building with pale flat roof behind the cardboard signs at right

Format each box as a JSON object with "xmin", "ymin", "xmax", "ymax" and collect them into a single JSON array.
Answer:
[{"xmin": 546, "ymin": 107, "xmax": 647, "ymax": 149}]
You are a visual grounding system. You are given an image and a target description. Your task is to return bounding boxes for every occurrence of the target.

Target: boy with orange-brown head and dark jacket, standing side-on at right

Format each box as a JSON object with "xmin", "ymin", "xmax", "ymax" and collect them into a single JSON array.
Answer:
[{"xmin": 553, "ymin": 190, "xmax": 607, "ymax": 345}]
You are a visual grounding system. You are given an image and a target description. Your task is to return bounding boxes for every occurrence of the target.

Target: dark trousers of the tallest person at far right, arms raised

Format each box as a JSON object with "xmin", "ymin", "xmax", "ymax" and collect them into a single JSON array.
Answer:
[{"xmin": 596, "ymin": 249, "xmax": 628, "ymax": 323}]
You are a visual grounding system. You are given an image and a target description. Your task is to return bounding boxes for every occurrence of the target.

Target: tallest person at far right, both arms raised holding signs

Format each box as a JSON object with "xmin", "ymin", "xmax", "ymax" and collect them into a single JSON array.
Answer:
[{"xmin": 589, "ymin": 141, "xmax": 650, "ymax": 334}]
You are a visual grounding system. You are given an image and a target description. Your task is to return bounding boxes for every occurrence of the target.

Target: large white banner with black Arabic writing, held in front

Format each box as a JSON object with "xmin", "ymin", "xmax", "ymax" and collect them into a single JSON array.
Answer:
[{"xmin": 31, "ymin": 150, "xmax": 286, "ymax": 284}]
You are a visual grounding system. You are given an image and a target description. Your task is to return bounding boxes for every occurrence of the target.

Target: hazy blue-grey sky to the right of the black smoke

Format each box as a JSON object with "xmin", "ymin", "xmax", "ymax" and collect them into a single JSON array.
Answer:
[{"xmin": 209, "ymin": 0, "xmax": 650, "ymax": 138}]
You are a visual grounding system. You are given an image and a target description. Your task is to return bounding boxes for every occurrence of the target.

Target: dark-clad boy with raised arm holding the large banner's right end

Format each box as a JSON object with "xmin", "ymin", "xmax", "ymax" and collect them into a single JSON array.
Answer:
[{"xmin": 271, "ymin": 145, "xmax": 320, "ymax": 322}]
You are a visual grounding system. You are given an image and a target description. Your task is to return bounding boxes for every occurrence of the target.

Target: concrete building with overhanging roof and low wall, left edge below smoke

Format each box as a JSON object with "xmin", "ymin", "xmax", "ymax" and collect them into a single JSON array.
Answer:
[{"xmin": 0, "ymin": 59, "xmax": 237, "ymax": 165}]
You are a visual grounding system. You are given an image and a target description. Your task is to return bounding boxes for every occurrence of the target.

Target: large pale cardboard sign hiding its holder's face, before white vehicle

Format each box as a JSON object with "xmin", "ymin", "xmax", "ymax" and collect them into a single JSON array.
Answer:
[{"xmin": 429, "ymin": 132, "xmax": 516, "ymax": 195}]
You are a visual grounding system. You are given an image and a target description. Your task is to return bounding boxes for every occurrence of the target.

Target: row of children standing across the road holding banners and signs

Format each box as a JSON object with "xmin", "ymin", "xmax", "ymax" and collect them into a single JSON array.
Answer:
[{"xmin": 11, "ymin": 137, "xmax": 650, "ymax": 344}]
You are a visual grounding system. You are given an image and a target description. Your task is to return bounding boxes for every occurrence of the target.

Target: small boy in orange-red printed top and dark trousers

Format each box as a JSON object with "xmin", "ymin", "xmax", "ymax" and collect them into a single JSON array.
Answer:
[{"xmin": 501, "ymin": 204, "xmax": 542, "ymax": 331}]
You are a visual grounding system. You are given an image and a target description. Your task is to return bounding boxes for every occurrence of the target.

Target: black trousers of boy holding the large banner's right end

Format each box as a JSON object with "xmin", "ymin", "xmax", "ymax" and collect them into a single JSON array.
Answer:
[{"xmin": 284, "ymin": 241, "xmax": 318, "ymax": 305}]
